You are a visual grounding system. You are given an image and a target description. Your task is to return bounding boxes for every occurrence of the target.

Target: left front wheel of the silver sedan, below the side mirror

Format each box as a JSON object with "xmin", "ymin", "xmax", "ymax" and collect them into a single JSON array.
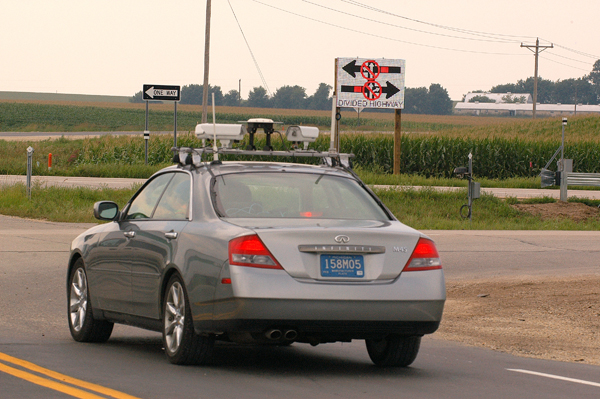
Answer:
[{"xmin": 67, "ymin": 258, "xmax": 113, "ymax": 342}]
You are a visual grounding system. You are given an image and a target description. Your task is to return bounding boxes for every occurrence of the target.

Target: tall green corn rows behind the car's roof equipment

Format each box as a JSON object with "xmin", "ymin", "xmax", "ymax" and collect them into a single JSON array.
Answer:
[{"xmin": 75, "ymin": 134, "xmax": 600, "ymax": 179}]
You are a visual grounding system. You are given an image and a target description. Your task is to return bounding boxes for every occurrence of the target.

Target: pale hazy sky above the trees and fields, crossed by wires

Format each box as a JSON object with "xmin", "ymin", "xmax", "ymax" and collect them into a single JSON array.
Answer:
[{"xmin": 0, "ymin": 0, "xmax": 600, "ymax": 100}]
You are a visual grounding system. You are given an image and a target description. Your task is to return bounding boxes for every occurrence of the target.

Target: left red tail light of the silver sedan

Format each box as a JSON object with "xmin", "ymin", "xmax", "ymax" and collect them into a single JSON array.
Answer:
[{"xmin": 229, "ymin": 234, "xmax": 283, "ymax": 269}]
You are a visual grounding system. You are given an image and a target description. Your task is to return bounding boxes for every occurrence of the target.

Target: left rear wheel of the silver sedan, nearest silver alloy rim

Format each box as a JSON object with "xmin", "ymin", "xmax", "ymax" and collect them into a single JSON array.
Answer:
[{"xmin": 163, "ymin": 275, "xmax": 214, "ymax": 364}]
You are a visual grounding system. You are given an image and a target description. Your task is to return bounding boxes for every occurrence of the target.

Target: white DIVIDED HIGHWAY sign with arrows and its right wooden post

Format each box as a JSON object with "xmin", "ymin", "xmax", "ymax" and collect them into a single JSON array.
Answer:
[{"xmin": 335, "ymin": 58, "xmax": 406, "ymax": 174}]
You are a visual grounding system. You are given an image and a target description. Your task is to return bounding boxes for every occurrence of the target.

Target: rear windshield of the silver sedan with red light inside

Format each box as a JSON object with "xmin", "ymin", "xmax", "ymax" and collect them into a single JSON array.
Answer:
[{"xmin": 213, "ymin": 172, "xmax": 389, "ymax": 220}]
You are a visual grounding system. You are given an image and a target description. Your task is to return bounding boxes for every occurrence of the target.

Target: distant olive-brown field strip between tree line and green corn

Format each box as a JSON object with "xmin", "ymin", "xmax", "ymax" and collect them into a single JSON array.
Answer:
[{"xmin": 0, "ymin": 100, "xmax": 514, "ymax": 132}]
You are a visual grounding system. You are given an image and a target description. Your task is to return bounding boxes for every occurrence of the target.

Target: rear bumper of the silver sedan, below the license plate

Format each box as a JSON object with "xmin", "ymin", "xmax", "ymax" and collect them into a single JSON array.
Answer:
[{"xmin": 190, "ymin": 267, "xmax": 446, "ymax": 338}]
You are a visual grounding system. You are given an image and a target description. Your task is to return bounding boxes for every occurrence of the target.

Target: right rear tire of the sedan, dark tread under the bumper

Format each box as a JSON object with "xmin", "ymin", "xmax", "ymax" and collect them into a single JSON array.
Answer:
[{"xmin": 365, "ymin": 335, "xmax": 421, "ymax": 367}]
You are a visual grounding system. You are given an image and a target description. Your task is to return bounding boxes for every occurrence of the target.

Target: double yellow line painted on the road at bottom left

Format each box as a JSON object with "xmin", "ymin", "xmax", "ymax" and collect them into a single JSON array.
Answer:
[{"xmin": 0, "ymin": 352, "xmax": 139, "ymax": 399}]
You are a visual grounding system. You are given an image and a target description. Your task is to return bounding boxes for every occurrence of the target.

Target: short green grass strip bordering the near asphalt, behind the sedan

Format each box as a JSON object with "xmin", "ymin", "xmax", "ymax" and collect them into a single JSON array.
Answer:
[{"xmin": 0, "ymin": 184, "xmax": 600, "ymax": 230}]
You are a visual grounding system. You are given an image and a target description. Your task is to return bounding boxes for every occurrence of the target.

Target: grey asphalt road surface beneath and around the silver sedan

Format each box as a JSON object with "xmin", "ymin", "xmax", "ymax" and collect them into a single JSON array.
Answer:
[{"xmin": 0, "ymin": 216, "xmax": 600, "ymax": 399}]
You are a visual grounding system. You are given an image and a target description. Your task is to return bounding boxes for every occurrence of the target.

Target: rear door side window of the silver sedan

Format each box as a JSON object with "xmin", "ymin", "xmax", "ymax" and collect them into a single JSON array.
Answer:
[{"xmin": 152, "ymin": 173, "xmax": 190, "ymax": 220}]
